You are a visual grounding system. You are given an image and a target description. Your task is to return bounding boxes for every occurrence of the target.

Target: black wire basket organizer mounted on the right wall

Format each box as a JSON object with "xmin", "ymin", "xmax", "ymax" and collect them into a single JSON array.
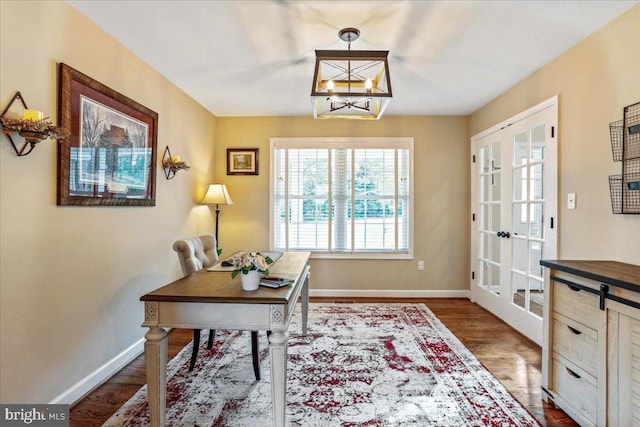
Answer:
[{"xmin": 609, "ymin": 102, "xmax": 640, "ymax": 214}]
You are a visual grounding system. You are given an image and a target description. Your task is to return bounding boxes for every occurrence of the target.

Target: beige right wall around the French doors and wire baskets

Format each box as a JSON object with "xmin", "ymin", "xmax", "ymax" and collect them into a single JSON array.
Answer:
[{"xmin": 470, "ymin": 5, "xmax": 640, "ymax": 264}]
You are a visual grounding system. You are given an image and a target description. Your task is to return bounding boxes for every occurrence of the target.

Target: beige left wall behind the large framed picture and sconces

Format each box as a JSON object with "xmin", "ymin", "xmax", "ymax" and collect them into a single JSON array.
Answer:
[{"xmin": 0, "ymin": 1, "xmax": 215, "ymax": 403}]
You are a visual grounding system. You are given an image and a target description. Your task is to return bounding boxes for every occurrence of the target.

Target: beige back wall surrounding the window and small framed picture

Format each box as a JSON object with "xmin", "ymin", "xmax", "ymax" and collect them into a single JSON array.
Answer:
[{"xmin": 215, "ymin": 116, "xmax": 469, "ymax": 295}]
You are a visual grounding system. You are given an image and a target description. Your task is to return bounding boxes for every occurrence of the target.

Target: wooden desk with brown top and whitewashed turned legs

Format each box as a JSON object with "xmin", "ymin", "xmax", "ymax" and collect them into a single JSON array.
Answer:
[{"xmin": 140, "ymin": 252, "xmax": 311, "ymax": 427}]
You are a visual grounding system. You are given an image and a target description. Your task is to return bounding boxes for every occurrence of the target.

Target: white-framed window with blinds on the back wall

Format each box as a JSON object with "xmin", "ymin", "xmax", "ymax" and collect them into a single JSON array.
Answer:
[{"xmin": 270, "ymin": 138, "xmax": 413, "ymax": 258}]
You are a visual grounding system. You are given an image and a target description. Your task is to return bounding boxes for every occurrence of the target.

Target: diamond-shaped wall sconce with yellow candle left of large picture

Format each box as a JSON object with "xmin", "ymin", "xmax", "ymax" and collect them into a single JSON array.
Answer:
[{"xmin": 0, "ymin": 92, "xmax": 70, "ymax": 157}]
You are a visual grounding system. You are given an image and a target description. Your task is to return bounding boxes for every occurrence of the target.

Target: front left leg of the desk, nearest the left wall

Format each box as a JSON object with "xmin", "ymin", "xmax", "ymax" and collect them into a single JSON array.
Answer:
[{"xmin": 144, "ymin": 326, "xmax": 168, "ymax": 427}]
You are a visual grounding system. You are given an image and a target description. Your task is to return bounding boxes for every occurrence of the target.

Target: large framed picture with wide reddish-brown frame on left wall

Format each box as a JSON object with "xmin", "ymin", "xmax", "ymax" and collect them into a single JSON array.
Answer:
[{"xmin": 57, "ymin": 63, "xmax": 158, "ymax": 206}]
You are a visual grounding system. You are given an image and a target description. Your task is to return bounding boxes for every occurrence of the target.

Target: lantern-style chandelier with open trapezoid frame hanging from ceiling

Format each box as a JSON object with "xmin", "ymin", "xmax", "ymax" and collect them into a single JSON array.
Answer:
[{"xmin": 311, "ymin": 28, "xmax": 392, "ymax": 120}]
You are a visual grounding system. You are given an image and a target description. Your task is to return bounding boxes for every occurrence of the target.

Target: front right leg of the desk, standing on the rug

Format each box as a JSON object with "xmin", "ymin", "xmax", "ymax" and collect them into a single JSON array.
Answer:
[{"xmin": 269, "ymin": 331, "xmax": 289, "ymax": 427}]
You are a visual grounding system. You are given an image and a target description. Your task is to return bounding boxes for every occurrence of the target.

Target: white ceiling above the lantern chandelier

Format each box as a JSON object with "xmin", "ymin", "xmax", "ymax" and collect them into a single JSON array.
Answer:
[{"xmin": 68, "ymin": 0, "xmax": 639, "ymax": 116}]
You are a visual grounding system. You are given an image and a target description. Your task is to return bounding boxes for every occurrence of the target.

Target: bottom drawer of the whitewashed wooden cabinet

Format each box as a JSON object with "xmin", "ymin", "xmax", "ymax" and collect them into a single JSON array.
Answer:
[{"xmin": 553, "ymin": 355, "xmax": 598, "ymax": 424}]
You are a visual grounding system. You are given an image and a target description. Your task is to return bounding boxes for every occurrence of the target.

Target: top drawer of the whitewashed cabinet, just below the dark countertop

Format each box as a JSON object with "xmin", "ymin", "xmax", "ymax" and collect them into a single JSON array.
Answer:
[{"xmin": 553, "ymin": 282, "xmax": 600, "ymax": 329}]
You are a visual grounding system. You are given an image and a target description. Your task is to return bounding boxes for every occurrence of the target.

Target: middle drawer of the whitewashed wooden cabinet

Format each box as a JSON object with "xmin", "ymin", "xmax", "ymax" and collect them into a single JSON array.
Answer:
[{"xmin": 553, "ymin": 313, "xmax": 598, "ymax": 378}]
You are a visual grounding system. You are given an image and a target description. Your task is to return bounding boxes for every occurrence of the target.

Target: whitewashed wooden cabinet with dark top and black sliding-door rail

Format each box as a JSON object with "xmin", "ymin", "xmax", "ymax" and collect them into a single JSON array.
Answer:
[{"xmin": 541, "ymin": 260, "xmax": 640, "ymax": 426}]
